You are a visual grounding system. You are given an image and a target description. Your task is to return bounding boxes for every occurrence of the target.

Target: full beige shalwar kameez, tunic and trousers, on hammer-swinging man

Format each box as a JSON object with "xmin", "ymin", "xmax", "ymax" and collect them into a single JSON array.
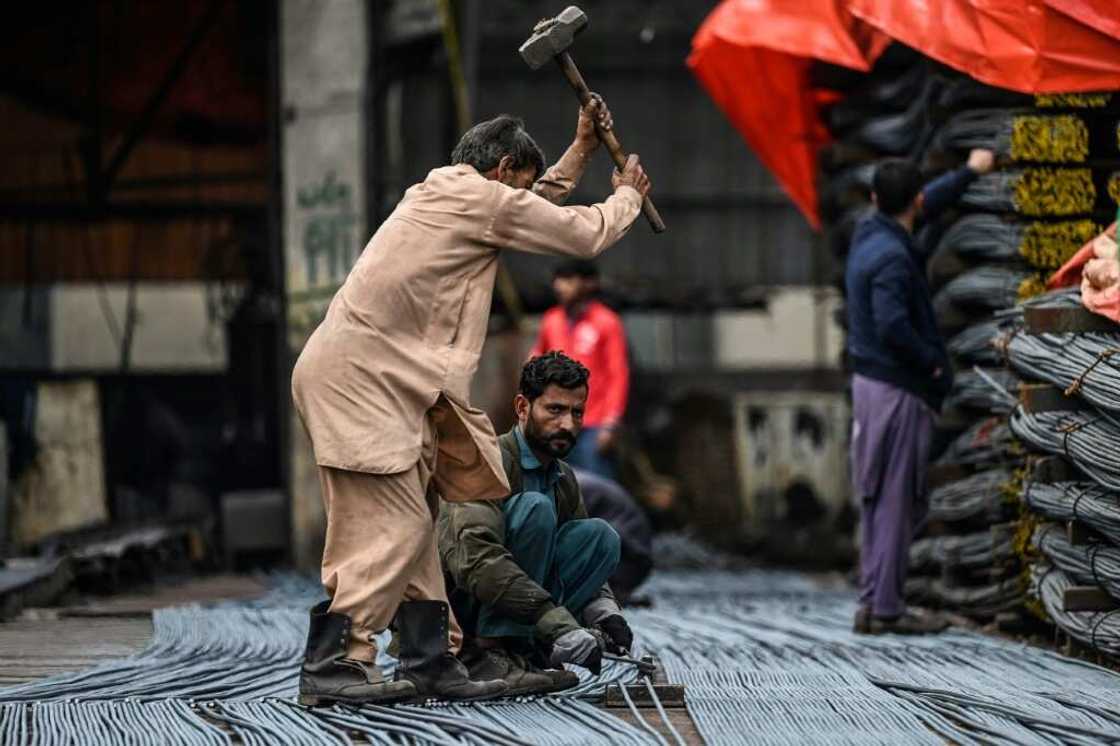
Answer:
[{"xmin": 292, "ymin": 149, "xmax": 642, "ymax": 661}]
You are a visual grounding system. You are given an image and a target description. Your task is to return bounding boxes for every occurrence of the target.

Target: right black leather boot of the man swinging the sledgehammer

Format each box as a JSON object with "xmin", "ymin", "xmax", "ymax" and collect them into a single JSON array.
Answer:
[{"xmin": 395, "ymin": 600, "xmax": 506, "ymax": 700}]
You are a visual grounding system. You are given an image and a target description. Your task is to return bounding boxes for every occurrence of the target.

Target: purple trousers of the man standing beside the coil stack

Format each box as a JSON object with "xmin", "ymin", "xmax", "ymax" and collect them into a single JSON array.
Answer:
[{"xmin": 851, "ymin": 375, "xmax": 933, "ymax": 617}]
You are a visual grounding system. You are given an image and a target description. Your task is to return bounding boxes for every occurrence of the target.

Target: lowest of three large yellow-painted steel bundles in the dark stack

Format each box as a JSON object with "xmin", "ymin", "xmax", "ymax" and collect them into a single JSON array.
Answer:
[{"xmin": 937, "ymin": 213, "xmax": 1103, "ymax": 270}]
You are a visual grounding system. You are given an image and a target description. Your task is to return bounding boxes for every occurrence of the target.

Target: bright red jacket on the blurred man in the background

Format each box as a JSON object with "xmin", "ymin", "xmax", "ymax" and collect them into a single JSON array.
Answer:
[{"xmin": 531, "ymin": 300, "xmax": 629, "ymax": 428}]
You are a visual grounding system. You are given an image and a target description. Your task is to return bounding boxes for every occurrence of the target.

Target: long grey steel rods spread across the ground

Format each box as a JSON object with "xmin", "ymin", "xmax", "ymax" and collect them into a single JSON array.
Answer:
[{"xmin": 0, "ymin": 556, "xmax": 1120, "ymax": 746}]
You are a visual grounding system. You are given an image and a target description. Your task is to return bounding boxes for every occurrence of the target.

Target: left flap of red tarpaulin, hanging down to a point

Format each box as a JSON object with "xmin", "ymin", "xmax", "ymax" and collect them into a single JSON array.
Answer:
[{"xmin": 689, "ymin": 0, "xmax": 889, "ymax": 227}]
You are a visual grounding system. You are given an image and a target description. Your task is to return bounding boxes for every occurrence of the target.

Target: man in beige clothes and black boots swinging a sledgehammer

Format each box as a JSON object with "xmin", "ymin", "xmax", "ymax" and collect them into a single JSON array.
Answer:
[{"xmin": 292, "ymin": 97, "xmax": 650, "ymax": 705}]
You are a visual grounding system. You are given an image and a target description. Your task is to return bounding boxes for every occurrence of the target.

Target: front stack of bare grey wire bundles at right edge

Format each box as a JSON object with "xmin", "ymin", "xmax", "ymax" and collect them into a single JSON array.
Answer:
[{"xmin": 1001, "ymin": 285, "xmax": 1120, "ymax": 656}]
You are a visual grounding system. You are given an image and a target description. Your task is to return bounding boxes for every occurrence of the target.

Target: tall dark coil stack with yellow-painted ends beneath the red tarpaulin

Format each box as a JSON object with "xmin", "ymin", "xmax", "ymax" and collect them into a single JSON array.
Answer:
[{"xmin": 821, "ymin": 63, "xmax": 1120, "ymax": 617}]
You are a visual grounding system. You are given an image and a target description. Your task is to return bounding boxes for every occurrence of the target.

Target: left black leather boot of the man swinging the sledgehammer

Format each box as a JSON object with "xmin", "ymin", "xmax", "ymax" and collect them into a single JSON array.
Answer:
[{"xmin": 299, "ymin": 602, "xmax": 417, "ymax": 707}]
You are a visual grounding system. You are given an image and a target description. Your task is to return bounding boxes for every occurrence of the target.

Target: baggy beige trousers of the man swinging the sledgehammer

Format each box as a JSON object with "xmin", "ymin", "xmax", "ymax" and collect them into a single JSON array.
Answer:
[{"xmin": 319, "ymin": 413, "xmax": 463, "ymax": 662}]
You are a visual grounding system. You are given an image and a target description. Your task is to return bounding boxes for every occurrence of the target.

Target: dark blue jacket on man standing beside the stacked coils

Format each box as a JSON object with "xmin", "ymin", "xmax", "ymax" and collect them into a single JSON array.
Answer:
[{"xmin": 844, "ymin": 168, "xmax": 976, "ymax": 409}]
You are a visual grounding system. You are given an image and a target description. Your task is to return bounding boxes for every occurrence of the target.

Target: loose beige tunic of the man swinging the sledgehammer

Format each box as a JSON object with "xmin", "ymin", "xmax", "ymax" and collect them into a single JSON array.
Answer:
[{"xmin": 292, "ymin": 156, "xmax": 641, "ymax": 501}]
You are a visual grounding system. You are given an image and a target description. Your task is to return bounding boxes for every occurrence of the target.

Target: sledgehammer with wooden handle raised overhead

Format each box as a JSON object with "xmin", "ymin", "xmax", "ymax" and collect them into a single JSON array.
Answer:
[{"xmin": 519, "ymin": 6, "xmax": 665, "ymax": 233}]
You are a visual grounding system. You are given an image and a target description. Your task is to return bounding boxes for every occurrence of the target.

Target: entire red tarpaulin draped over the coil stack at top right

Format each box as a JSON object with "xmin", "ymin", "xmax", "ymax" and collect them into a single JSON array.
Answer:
[{"xmin": 689, "ymin": 0, "xmax": 1120, "ymax": 227}]
